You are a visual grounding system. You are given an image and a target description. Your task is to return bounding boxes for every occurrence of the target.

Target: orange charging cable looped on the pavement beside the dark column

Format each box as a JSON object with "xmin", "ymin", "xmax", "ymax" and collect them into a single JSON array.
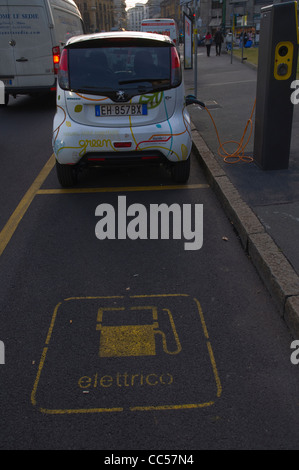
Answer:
[{"xmin": 203, "ymin": 99, "xmax": 256, "ymax": 164}]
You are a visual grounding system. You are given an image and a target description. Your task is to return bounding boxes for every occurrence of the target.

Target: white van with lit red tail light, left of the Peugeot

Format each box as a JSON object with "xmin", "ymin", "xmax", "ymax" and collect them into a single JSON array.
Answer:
[{"xmin": 0, "ymin": 0, "xmax": 84, "ymax": 104}]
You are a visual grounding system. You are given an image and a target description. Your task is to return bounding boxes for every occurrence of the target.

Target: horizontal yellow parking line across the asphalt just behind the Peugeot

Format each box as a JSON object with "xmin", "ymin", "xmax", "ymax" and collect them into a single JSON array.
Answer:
[{"xmin": 36, "ymin": 184, "xmax": 210, "ymax": 194}]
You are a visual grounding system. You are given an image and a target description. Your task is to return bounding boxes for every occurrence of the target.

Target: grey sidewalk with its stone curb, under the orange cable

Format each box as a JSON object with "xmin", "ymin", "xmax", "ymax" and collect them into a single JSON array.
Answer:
[{"xmin": 184, "ymin": 46, "xmax": 299, "ymax": 338}]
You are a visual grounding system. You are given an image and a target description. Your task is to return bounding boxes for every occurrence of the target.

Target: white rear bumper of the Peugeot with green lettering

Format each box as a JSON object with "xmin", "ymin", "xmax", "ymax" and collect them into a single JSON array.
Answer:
[{"xmin": 52, "ymin": 107, "xmax": 192, "ymax": 164}]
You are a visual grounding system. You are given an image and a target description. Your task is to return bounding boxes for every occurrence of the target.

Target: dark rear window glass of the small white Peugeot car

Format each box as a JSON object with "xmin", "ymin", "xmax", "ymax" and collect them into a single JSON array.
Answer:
[{"xmin": 68, "ymin": 44, "xmax": 171, "ymax": 96}]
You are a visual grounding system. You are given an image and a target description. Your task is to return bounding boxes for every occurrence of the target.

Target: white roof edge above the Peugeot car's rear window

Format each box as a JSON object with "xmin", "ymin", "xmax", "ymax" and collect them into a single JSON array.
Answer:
[{"xmin": 67, "ymin": 31, "xmax": 174, "ymax": 45}]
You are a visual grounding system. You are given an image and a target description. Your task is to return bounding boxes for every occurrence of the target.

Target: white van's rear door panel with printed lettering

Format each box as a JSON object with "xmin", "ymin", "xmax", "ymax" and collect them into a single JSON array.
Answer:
[{"xmin": 0, "ymin": 0, "xmax": 55, "ymax": 88}]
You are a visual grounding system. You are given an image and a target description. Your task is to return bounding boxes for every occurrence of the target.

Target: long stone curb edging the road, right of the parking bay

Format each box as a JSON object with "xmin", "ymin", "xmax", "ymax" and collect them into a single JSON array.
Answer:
[{"xmin": 191, "ymin": 122, "xmax": 299, "ymax": 339}]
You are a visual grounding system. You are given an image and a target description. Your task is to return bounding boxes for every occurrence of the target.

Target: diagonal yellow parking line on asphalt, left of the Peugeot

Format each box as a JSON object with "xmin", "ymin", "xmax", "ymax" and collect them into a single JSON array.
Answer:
[{"xmin": 0, "ymin": 154, "xmax": 55, "ymax": 256}]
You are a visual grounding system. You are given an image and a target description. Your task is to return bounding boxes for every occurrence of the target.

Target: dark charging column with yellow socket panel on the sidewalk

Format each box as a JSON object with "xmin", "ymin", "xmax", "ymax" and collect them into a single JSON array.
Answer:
[{"xmin": 254, "ymin": 2, "xmax": 299, "ymax": 170}]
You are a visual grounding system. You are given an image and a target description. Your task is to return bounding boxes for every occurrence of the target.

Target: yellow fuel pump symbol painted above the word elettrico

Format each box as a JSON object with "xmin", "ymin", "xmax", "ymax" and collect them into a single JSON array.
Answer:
[{"xmin": 96, "ymin": 306, "xmax": 182, "ymax": 357}]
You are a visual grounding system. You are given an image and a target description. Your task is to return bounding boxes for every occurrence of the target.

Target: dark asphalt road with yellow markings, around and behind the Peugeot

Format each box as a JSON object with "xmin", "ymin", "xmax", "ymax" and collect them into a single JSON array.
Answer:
[{"xmin": 0, "ymin": 93, "xmax": 299, "ymax": 452}]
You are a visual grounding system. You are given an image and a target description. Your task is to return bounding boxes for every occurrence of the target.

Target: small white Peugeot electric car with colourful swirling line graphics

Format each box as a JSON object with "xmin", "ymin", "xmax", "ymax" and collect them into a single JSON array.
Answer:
[{"xmin": 53, "ymin": 31, "xmax": 192, "ymax": 187}]
